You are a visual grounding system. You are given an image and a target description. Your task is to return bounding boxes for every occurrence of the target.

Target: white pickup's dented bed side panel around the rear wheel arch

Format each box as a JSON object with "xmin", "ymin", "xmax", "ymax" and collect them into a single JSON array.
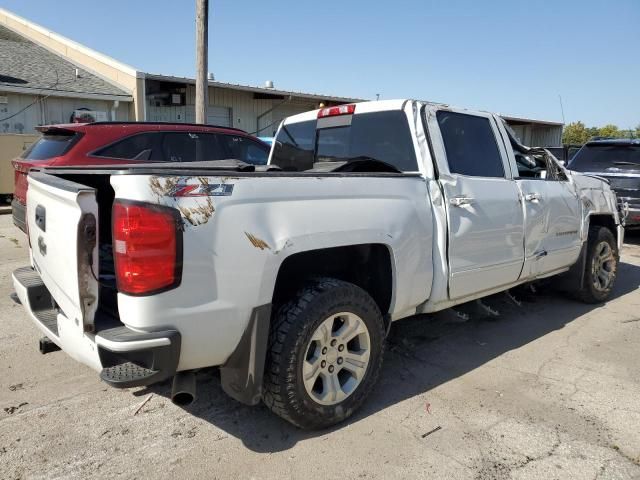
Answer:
[{"xmin": 111, "ymin": 175, "xmax": 433, "ymax": 370}]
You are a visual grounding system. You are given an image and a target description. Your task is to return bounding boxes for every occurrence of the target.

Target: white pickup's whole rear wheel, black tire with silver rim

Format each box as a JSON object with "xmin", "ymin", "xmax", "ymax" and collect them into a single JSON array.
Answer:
[{"xmin": 263, "ymin": 278, "xmax": 385, "ymax": 429}]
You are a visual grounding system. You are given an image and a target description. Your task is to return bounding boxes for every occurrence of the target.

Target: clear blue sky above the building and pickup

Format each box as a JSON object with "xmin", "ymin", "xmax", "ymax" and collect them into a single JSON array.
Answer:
[{"xmin": 0, "ymin": 0, "xmax": 640, "ymax": 128}]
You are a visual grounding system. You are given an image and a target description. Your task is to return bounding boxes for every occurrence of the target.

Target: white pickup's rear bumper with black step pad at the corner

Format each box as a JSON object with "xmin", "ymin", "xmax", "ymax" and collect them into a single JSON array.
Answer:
[{"xmin": 13, "ymin": 267, "xmax": 181, "ymax": 388}]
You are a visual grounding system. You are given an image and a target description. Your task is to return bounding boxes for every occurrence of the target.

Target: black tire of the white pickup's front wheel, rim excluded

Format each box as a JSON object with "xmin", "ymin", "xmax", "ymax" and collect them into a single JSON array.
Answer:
[{"xmin": 576, "ymin": 225, "xmax": 620, "ymax": 303}]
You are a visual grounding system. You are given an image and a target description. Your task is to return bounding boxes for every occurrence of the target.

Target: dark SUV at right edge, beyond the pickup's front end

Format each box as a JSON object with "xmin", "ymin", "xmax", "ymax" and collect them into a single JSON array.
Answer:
[{"xmin": 568, "ymin": 139, "xmax": 640, "ymax": 228}]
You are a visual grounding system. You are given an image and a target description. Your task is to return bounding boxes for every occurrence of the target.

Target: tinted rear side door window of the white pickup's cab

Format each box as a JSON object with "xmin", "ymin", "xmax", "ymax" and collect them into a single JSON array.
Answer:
[{"xmin": 436, "ymin": 110, "xmax": 504, "ymax": 177}]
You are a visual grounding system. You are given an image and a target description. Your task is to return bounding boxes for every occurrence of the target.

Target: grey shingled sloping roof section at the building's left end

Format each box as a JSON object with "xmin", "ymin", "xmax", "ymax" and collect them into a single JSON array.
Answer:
[{"xmin": 0, "ymin": 25, "xmax": 132, "ymax": 101}]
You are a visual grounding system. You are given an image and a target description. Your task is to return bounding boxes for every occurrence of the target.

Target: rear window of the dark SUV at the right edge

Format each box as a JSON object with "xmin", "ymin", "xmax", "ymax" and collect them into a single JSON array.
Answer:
[{"xmin": 569, "ymin": 144, "xmax": 640, "ymax": 172}]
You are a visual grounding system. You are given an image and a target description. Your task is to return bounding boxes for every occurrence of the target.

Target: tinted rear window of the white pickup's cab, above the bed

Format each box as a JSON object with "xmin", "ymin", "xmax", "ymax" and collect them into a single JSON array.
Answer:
[{"xmin": 271, "ymin": 110, "xmax": 418, "ymax": 172}]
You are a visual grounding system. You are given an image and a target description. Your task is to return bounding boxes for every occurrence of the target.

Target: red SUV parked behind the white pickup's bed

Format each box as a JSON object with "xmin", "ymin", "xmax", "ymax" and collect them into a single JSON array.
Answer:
[{"xmin": 11, "ymin": 122, "xmax": 269, "ymax": 231}]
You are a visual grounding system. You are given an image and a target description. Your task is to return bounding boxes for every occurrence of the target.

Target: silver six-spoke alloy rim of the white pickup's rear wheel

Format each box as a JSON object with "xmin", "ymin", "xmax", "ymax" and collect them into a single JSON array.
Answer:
[{"xmin": 302, "ymin": 312, "xmax": 371, "ymax": 405}]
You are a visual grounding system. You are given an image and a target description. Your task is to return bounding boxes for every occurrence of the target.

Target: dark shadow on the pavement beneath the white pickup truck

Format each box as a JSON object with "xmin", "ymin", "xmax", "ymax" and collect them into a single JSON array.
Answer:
[{"xmin": 135, "ymin": 256, "xmax": 640, "ymax": 452}]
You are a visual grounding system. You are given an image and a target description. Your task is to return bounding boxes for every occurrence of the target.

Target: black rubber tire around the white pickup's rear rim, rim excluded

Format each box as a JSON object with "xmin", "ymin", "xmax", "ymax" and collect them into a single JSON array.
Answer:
[{"xmin": 262, "ymin": 278, "xmax": 385, "ymax": 429}]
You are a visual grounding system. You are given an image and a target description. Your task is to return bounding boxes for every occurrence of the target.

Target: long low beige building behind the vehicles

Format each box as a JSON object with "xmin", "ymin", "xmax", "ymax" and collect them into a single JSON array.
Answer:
[{"xmin": 0, "ymin": 8, "xmax": 562, "ymax": 146}]
